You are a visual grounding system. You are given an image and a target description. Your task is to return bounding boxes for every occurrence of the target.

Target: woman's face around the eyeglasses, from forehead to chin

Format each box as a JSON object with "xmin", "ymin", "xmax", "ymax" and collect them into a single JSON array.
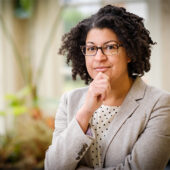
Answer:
[{"xmin": 85, "ymin": 28, "xmax": 130, "ymax": 81}]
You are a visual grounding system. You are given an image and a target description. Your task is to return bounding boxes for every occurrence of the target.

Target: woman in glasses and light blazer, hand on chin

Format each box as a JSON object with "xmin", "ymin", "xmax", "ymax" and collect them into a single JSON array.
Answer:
[{"xmin": 45, "ymin": 5, "xmax": 170, "ymax": 170}]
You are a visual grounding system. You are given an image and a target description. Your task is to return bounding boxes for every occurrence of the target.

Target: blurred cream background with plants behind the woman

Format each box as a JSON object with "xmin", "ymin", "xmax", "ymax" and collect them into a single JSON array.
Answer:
[{"xmin": 0, "ymin": 0, "xmax": 170, "ymax": 169}]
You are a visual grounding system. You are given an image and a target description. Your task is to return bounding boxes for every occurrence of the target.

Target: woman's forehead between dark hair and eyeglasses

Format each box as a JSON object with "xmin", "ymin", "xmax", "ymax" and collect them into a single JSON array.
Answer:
[{"xmin": 86, "ymin": 28, "xmax": 119, "ymax": 45}]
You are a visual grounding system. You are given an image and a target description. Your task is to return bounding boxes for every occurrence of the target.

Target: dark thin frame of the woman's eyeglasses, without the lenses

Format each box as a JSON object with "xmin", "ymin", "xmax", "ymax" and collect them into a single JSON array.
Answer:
[{"xmin": 80, "ymin": 40, "xmax": 123, "ymax": 56}]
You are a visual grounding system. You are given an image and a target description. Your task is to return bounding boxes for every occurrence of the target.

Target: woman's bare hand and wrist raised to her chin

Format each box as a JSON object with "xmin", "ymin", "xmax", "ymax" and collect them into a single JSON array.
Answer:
[{"xmin": 76, "ymin": 72, "xmax": 111, "ymax": 132}]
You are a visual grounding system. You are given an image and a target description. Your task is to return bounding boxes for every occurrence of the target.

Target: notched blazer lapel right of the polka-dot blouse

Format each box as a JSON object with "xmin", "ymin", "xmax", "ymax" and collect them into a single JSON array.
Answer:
[{"xmin": 101, "ymin": 78, "xmax": 146, "ymax": 162}]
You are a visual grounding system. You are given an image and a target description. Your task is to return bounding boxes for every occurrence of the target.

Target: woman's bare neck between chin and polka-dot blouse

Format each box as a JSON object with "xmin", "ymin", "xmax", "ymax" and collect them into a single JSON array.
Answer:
[{"xmin": 103, "ymin": 76, "xmax": 133, "ymax": 106}]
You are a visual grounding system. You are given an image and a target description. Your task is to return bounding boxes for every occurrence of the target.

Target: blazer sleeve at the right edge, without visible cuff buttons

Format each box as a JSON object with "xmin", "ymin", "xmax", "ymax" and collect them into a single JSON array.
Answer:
[{"xmin": 94, "ymin": 94, "xmax": 170, "ymax": 170}]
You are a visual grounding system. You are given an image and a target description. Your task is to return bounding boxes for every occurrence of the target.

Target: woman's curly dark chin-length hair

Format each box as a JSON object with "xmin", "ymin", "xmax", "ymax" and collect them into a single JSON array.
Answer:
[{"xmin": 59, "ymin": 5, "xmax": 155, "ymax": 84}]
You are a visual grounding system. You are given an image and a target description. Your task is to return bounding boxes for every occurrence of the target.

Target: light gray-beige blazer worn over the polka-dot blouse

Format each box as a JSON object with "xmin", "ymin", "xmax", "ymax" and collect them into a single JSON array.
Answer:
[{"xmin": 45, "ymin": 78, "xmax": 170, "ymax": 170}]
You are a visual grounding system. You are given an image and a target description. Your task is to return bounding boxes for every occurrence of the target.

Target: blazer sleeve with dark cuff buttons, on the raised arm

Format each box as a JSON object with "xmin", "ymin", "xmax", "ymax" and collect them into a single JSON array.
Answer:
[{"xmin": 45, "ymin": 94, "xmax": 93, "ymax": 170}]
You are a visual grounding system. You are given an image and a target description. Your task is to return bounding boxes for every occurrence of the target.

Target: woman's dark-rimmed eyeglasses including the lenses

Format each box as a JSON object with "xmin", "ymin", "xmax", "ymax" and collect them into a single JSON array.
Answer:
[{"xmin": 80, "ymin": 42, "xmax": 123, "ymax": 56}]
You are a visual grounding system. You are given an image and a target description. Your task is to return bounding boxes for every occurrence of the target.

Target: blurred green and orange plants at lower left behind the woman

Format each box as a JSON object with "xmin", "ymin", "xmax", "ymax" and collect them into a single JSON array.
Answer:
[{"xmin": 0, "ymin": 87, "xmax": 54, "ymax": 169}]
